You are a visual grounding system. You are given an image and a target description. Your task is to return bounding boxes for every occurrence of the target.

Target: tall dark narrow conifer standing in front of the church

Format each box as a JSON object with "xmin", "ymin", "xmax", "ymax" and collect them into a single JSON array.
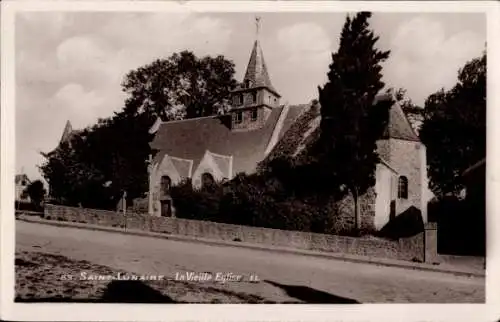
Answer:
[{"xmin": 313, "ymin": 12, "xmax": 393, "ymax": 230}]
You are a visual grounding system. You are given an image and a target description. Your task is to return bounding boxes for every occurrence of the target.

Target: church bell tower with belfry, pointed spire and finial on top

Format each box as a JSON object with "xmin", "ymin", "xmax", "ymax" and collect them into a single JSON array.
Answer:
[{"xmin": 230, "ymin": 17, "xmax": 281, "ymax": 130}]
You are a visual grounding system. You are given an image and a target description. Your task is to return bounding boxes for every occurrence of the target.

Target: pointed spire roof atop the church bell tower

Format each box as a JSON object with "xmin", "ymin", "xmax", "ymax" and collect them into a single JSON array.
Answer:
[{"xmin": 243, "ymin": 40, "xmax": 279, "ymax": 96}]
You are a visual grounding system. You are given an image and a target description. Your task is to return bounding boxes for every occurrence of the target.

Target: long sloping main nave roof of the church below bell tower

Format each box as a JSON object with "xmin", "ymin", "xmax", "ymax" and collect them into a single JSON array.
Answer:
[{"xmin": 151, "ymin": 105, "xmax": 304, "ymax": 175}]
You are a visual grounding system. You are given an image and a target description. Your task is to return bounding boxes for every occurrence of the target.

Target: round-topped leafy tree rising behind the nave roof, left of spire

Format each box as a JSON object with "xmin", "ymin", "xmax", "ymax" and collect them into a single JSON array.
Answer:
[{"xmin": 122, "ymin": 51, "xmax": 236, "ymax": 121}]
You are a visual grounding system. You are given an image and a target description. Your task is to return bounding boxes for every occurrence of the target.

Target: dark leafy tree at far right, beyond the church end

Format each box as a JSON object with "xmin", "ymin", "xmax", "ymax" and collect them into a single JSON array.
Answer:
[{"xmin": 420, "ymin": 52, "xmax": 486, "ymax": 196}]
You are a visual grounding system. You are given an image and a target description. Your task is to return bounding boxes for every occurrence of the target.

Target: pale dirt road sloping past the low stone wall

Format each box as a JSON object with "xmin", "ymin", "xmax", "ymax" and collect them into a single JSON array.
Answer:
[{"xmin": 16, "ymin": 221, "xmax": 485, "ymax": 303}]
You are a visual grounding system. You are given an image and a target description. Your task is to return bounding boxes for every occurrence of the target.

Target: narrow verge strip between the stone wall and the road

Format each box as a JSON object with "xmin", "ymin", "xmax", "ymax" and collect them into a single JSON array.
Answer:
[{"xmin": 16, "ymin": 215, "xmax": 485, "ymax": 278}]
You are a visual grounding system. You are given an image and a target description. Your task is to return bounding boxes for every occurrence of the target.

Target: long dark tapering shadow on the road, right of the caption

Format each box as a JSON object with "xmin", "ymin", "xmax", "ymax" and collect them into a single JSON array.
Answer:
[{"xmin": 265, "ymin": 280, "xmax": 360, "ymax": 304}]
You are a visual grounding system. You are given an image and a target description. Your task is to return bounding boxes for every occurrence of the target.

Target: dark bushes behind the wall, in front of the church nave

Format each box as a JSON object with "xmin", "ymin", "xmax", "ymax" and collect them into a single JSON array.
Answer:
[{"xmin": 171, "ymin": 173, "xmax": 358, "ymax": 234}]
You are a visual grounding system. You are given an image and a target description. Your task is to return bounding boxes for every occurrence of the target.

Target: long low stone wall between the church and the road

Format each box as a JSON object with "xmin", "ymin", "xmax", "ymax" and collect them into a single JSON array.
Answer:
[{"xmin": 44, "ymin": 205, "xmax": 426, "ymax": 261}]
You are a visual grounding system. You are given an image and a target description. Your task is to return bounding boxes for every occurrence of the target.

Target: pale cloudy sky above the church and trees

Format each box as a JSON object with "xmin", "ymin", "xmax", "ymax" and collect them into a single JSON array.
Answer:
[{"xmin": 15, "ymin": 12, "xmax": 486, "ymax": 180}]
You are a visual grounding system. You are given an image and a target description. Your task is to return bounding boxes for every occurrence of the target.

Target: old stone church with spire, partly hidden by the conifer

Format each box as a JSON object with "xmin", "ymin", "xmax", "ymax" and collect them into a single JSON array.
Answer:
[{"xmin": 148, "ymin": 26, "xmax": 427, "ymax": 229}]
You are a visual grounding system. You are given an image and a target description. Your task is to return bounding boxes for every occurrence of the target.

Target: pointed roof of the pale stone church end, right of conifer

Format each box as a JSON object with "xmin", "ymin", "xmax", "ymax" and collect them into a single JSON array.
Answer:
[{"xmin": 374, "ymin": 94, "xmax": 420, "ymax": 142}]
